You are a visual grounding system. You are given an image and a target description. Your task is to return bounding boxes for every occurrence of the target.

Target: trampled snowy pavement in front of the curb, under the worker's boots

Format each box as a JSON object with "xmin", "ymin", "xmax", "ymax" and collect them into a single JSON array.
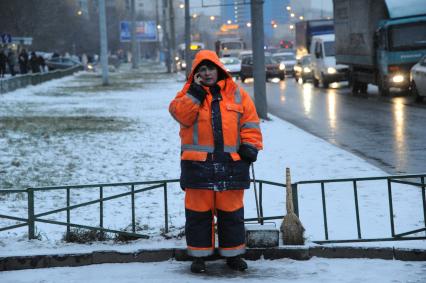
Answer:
[{"xmin": 0, "ymin": 258, "xmax": 426, "ymax": 283}]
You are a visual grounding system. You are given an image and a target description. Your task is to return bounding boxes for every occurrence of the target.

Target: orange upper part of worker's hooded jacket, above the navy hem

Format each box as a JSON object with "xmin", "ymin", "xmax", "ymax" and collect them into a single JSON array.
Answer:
[{"xmin": 169, "ymin": 50, "xmax": 262, "ymax": 161}]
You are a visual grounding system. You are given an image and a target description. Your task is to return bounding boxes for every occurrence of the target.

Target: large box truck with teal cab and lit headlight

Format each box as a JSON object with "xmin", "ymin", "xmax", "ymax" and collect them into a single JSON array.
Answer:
[{"xmin": 333, "ymin": 0, "xmax": 426, "ymax": 96}]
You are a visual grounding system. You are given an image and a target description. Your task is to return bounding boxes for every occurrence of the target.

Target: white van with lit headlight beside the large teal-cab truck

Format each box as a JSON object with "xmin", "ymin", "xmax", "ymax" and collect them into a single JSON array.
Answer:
[{"xmin": 310, "ymin": 34, "xmax": 349, "ymax": 88}]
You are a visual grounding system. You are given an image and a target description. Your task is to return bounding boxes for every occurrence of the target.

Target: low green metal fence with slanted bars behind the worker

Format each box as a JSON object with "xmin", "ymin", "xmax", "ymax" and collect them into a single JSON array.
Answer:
[{"xmin": 0, "ymin": 174, "xmax": 426, "ymax": 244}]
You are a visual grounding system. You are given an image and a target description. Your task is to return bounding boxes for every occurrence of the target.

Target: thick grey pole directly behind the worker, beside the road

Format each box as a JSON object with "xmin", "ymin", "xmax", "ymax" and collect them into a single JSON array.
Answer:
[{"xmin": 250, "ymin": 0, "xmax": 268, "ymax": 119}]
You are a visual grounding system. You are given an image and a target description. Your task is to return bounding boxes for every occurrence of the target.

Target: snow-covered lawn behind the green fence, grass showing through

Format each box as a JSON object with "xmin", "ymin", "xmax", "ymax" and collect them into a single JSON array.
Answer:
[{"xmin": 0, "ymin": 62, "xmax": 426, "ymax": 276}]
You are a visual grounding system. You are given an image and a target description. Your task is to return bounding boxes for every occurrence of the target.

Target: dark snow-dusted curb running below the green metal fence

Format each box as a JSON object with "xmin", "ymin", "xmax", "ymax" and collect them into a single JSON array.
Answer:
[{"xmin": 0, "ymin": 246, "xmax": 426, "ymax": 271}]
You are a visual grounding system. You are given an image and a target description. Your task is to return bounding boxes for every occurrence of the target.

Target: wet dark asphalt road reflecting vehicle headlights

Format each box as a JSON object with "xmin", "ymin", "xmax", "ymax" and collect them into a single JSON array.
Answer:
[{"xmin": 242, "ymin": 78, "xmax": 426, "ymax": 174}]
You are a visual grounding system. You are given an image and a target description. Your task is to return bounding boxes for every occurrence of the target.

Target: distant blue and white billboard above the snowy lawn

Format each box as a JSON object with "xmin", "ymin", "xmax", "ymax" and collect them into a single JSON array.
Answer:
[{"xmin": 120, "ymin": 21, "xmax": 158, "ymax": 42}]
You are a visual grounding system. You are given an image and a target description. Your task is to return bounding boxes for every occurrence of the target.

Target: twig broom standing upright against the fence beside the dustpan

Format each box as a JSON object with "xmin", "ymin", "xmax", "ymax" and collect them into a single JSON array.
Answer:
[{"xmin": 280, "ymin": 168, "xmax": 305, "ymax": 245}]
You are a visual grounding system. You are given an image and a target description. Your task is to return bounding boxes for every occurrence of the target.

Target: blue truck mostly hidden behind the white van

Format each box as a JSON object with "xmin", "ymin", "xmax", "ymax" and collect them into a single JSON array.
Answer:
[{"xmin": 296, "ymin": 19, "xmax": 334, "ymax": 60}]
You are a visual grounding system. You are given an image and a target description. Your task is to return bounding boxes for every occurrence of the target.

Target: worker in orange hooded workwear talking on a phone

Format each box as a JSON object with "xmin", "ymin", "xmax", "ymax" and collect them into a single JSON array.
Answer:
[{"xmin": 169, "ymin": 50, "xmax": 262, "ymax": 273}]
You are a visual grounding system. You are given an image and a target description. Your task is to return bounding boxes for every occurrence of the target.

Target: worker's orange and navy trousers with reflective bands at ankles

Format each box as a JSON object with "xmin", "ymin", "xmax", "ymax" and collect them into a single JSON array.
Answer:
[{"xmin": 185, "ymin": 188, "xmax": 245, "ymax": 257}]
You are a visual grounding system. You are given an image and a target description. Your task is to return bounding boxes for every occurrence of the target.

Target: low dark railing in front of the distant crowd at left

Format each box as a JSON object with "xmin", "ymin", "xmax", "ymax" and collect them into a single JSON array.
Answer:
[{"xmin": 0, "ymin": 66, "xmax": 83, "ymax": 94}]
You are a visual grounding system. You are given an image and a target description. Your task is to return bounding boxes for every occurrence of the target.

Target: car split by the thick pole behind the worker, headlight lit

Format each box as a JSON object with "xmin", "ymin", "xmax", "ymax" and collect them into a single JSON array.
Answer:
[{"xmin": 240, "ymin": 54, "xmax": 285, "ymax": 82}]
